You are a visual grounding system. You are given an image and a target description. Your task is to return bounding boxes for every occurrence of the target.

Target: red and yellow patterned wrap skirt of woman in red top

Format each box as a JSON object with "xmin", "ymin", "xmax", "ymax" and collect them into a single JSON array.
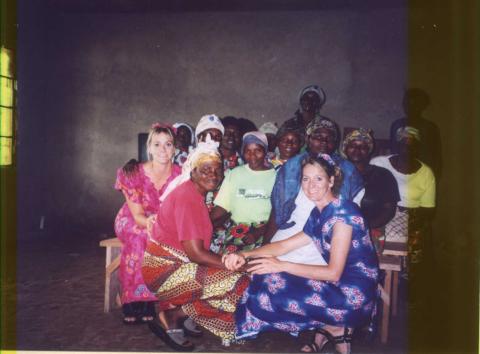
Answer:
[{"xmin": 142, "ymin": 240, "xmax": 250, "ymax": 340}]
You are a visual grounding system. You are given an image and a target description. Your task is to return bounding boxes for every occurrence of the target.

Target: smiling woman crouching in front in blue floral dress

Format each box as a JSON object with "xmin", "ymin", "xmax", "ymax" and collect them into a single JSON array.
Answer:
[{"xmin": 223, "ymin": 154, "xmax": 378, "ymax": 353}]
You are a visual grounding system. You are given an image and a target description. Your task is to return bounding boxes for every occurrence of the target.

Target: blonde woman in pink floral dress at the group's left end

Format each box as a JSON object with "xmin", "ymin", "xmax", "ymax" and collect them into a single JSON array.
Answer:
[{"xmin": 115, "ymin": 123, "xmax": 181, "ymax": 324}]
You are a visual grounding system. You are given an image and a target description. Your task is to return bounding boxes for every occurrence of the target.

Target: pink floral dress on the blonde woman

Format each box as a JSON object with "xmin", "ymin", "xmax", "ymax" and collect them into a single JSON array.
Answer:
[{"xmin": 115, "ymin": 164, "xmax": 182, "ymax": 304}]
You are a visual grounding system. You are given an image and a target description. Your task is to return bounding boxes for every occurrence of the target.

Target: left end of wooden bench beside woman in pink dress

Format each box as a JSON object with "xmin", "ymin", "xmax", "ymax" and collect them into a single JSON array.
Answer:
[{"xmin": 100, "ymin": 237, "xmax": 122, "ymax": 313}]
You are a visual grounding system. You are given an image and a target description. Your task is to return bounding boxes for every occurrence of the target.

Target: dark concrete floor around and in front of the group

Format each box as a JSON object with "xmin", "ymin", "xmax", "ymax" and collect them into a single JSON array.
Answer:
[{"xmin": 3, "ymin": 236, "xmax": 407, "ymax": 353}]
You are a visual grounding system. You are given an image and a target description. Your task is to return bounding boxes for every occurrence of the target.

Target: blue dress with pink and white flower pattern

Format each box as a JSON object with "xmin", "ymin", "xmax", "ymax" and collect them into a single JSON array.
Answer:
[{"xmin": 235, "ymin": 199, "xmax": 378, "ymax": 339}]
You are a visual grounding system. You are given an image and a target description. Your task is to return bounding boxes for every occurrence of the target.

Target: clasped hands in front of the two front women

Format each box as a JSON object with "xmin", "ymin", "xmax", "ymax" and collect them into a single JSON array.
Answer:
[{"xmin": 222, "ymin": 253, "xmax": 284, "ymax": 274}]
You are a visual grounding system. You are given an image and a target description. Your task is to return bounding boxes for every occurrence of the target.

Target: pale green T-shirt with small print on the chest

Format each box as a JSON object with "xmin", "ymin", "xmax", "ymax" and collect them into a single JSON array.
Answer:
[{"xmin": 214, "ymin": 165, "xmax": 276, "ymax": 224}]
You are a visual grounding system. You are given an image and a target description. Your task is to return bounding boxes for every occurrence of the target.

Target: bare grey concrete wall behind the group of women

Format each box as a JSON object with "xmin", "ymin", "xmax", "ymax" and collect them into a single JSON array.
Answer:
[{"xmin": 18, "ymin": 5, "xmax": 406, "ymax": 233}]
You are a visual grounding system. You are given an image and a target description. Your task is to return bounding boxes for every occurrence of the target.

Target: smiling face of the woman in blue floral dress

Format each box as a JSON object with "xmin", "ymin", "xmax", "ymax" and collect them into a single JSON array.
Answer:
[{"xmin": 302, "ymin": 163, "xmax": 334, "ymax": 202}]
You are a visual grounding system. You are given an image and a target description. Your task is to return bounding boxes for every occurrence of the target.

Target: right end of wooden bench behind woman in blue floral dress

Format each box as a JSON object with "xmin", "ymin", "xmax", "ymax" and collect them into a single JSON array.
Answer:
[{"xmin": 379, "ymin": 242, "xmax": 407, "ymax": 343}]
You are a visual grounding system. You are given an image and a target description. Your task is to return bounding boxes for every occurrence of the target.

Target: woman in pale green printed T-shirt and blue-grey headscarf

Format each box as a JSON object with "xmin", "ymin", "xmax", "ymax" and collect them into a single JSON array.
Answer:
[{"xmin": 210, "ymin": 132, "xmax": 275, "ymax": 254}]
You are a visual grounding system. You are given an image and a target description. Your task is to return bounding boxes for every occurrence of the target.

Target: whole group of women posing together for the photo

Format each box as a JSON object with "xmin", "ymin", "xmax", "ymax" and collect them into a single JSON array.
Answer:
[{"xmin": 115, "ymin": 85, "xmax": 435, "ymax": 353}]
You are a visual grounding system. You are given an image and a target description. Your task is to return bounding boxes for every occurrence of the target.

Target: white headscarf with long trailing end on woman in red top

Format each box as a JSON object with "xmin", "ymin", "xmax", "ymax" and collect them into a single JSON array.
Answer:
[{"xmin": 160, "ymin": 136, "xmax": 222, "ymax": 202}]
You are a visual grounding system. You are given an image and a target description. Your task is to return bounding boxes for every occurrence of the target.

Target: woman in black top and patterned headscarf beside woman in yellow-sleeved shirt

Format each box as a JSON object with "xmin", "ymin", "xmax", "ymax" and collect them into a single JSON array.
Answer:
[{"xmin": 341, "ymin": 128, "xmax": 400, "ymax": 253}]
